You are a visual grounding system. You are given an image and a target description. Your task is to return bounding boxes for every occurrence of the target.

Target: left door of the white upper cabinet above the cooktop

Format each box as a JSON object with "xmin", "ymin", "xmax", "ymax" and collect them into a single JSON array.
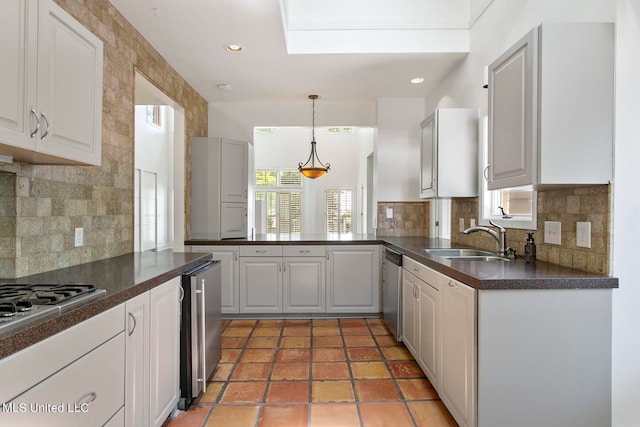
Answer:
[{"xmin": 0, "ymin": 0, "xmax": 37, "ymax": 154}]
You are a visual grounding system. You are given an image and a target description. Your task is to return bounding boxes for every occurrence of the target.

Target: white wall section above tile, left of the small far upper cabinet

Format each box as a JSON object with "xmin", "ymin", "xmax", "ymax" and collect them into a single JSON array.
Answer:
[{"xmin": 375, "ymin": 98, "xmax": 427, "ymax": 202}]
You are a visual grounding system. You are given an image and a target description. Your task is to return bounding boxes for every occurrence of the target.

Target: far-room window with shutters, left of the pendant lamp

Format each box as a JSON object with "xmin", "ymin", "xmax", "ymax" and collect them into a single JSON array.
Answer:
[{"xmin": 255, "ymin": 169, "xmax": 302, "ymax": 234}]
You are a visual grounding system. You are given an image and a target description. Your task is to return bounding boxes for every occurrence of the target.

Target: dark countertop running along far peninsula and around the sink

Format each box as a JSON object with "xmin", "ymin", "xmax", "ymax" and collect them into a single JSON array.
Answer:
[{"xmin": 185, "ymin": 234, "xmax": 618, "ymax": 290}]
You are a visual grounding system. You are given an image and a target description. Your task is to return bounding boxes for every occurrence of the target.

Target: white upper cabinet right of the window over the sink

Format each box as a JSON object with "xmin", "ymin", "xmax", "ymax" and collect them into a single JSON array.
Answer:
[{"xmin": 485, "ymin": 23, "xmax": 614, "ymax": 190}]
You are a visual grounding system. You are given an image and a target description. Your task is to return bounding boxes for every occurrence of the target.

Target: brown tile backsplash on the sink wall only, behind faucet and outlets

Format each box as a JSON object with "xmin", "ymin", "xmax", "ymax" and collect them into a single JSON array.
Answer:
[{"xmin": 451, "ymin": 185, "xmax": 611, "ymax": 274}]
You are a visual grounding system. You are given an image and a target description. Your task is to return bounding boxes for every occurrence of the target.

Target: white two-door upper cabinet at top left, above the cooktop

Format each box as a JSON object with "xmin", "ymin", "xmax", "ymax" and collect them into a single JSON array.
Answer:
[{"xmin": 0, "ymin": 0, "xmax": 103, "ymax": 165}]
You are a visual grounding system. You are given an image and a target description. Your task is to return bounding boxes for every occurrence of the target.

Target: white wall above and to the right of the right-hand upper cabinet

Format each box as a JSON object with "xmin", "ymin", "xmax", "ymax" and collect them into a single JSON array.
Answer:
[{"xmin": 426, "ymin": 0, "xmax": 640, "ymax": 427}]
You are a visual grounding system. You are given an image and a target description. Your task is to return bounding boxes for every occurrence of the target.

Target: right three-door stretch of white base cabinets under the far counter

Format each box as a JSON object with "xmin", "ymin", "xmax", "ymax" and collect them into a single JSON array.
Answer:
[{"xmin": 191, "ymin": 244, "xmax": 380, "ymax": 314}]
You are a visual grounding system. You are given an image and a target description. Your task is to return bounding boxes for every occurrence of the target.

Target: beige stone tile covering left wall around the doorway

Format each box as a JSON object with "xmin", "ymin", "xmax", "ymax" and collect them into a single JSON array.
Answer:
[{"xmin": 0, "ymin": 0, "xmax": 208, "ymax": 278}]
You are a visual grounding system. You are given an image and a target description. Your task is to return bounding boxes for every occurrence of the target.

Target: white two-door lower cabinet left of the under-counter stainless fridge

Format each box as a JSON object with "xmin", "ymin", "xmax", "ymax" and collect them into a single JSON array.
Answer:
[{"xmin": 125, "ymin": 277, "xmax": 181, "ymax": 427}]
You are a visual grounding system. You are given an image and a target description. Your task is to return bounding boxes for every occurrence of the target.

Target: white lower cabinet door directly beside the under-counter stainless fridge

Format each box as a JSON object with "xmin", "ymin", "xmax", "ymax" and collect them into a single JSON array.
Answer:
[{"xmin": 149, "ymin": 277, "xmax": 181, "ymax": 427}]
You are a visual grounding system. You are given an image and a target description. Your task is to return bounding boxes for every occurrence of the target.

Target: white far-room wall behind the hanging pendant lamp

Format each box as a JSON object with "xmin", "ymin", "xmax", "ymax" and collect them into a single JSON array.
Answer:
[{"xmin": 254, "ymin": 127, "xmax": 373, "ymax": 234}]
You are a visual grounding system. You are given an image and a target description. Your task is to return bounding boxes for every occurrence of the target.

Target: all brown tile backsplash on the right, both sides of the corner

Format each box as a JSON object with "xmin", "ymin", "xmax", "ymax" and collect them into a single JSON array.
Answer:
[{"xmin": 376, "ymin": 185, "xmax": 611, "ymax": 274}]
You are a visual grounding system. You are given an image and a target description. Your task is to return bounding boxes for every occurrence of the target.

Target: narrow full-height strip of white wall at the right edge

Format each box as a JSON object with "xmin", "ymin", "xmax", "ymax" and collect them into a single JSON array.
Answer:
[{"xmin": 612, "ymin": 0, "xmax": 640, "ymax": 427}]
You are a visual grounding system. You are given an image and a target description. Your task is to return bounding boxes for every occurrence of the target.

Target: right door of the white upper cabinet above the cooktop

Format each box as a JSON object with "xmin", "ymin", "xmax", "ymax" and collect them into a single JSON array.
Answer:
[{"xmin": 37, "ymin": 0, "xmax": 103, "ymax": 165}]
